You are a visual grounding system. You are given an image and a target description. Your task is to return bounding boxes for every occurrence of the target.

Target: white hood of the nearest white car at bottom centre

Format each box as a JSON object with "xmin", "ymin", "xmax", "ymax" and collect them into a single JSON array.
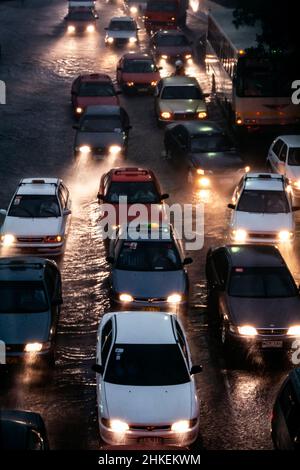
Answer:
[{"xmin": 104, "ymin": 382, "xmax": 194, "ymax": 425}]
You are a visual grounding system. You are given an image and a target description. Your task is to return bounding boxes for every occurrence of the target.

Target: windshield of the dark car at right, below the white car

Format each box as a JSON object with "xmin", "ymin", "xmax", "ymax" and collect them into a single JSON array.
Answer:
[{"xmin": 229, "ymin": 267, "xmax": 298, "ymax": 298}]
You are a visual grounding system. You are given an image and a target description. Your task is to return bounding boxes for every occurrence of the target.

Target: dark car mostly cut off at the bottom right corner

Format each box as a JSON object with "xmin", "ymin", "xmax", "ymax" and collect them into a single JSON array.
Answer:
[{"xmin": 271, "ymin": 369, "xmax": 300, "ymax": 451}]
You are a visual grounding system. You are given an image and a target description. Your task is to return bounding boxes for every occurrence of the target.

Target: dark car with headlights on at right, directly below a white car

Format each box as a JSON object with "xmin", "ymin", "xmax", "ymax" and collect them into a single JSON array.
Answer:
[{"xmin": 206, "ymin": 245, "xmax": 300, "ymax": 353}]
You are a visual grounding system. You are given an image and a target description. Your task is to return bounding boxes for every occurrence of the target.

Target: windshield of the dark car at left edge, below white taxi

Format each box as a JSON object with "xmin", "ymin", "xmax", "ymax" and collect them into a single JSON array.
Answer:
[{"xmin": 0, "ymin": 281, "xmax": 49, "ymax": 313}]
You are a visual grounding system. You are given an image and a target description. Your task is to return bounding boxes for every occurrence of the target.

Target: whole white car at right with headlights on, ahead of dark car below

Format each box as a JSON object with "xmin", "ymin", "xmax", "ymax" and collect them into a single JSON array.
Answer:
[{"xmin": 228, "ymin": 173, "xmax": 299, "ymax": 244}]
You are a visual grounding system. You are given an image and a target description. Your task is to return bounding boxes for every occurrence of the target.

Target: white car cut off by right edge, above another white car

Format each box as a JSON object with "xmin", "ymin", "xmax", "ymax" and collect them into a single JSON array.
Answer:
[{"xmin": 267, "ymin": 135, "xmax": 300, "ymax": 199}]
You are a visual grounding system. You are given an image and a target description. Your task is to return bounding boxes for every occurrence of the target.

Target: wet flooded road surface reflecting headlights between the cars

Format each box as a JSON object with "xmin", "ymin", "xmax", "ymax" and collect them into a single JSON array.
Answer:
[{"xmin": 0, "ymin": 0, "xmax": 300, "ymax": 449}]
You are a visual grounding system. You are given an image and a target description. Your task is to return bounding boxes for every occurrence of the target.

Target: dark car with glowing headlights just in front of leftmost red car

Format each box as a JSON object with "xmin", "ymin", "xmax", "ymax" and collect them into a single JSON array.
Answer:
[{"xmin": 73, "ymin": 106, "xmax": 131, "ymax": 160}]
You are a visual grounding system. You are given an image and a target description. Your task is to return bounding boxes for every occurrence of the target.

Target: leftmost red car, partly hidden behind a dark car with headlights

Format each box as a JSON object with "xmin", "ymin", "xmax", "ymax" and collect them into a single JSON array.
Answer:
[{"xmin": 71, "ymin": 73, "xmax": 120, "ymax": 117}]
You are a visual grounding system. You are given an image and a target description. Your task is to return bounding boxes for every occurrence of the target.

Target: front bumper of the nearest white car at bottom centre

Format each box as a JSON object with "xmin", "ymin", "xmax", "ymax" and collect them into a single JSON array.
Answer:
[{"xmin": 99, "ymin": 420, "xmax": 199, "ymax": 447}]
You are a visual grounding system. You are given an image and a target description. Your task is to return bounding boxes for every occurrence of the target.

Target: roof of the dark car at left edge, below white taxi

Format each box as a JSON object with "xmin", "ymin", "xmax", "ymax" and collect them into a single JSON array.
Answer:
[{"xmin": 0, "ymin": 256, "xmax": 51, "ymax": 281}]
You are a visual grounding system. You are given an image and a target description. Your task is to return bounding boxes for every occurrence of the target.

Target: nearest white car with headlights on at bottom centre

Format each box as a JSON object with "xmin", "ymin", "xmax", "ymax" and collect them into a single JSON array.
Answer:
[{"xmin": 93, "ymin": 311, "xmax": 202, "ymax": 446}]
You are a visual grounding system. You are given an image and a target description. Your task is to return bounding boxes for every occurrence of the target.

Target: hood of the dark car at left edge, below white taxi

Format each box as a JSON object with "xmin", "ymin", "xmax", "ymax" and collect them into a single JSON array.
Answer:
[{"xmin": 0, "ymin": 312, "xmax": 50, "ymax": 344}]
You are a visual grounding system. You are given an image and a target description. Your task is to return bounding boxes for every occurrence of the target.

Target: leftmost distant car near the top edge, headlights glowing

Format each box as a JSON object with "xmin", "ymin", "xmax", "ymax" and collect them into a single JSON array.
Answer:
[{"xmin": 65, "ymin": 7, "xmax": 99, "ymax": 34}]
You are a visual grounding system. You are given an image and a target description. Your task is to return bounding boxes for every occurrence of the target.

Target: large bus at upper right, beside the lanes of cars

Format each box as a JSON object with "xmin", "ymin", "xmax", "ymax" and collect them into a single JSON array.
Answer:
[{"xmin": 205, "ymin": 2, "xmax": 300, "ymax": 132}]
